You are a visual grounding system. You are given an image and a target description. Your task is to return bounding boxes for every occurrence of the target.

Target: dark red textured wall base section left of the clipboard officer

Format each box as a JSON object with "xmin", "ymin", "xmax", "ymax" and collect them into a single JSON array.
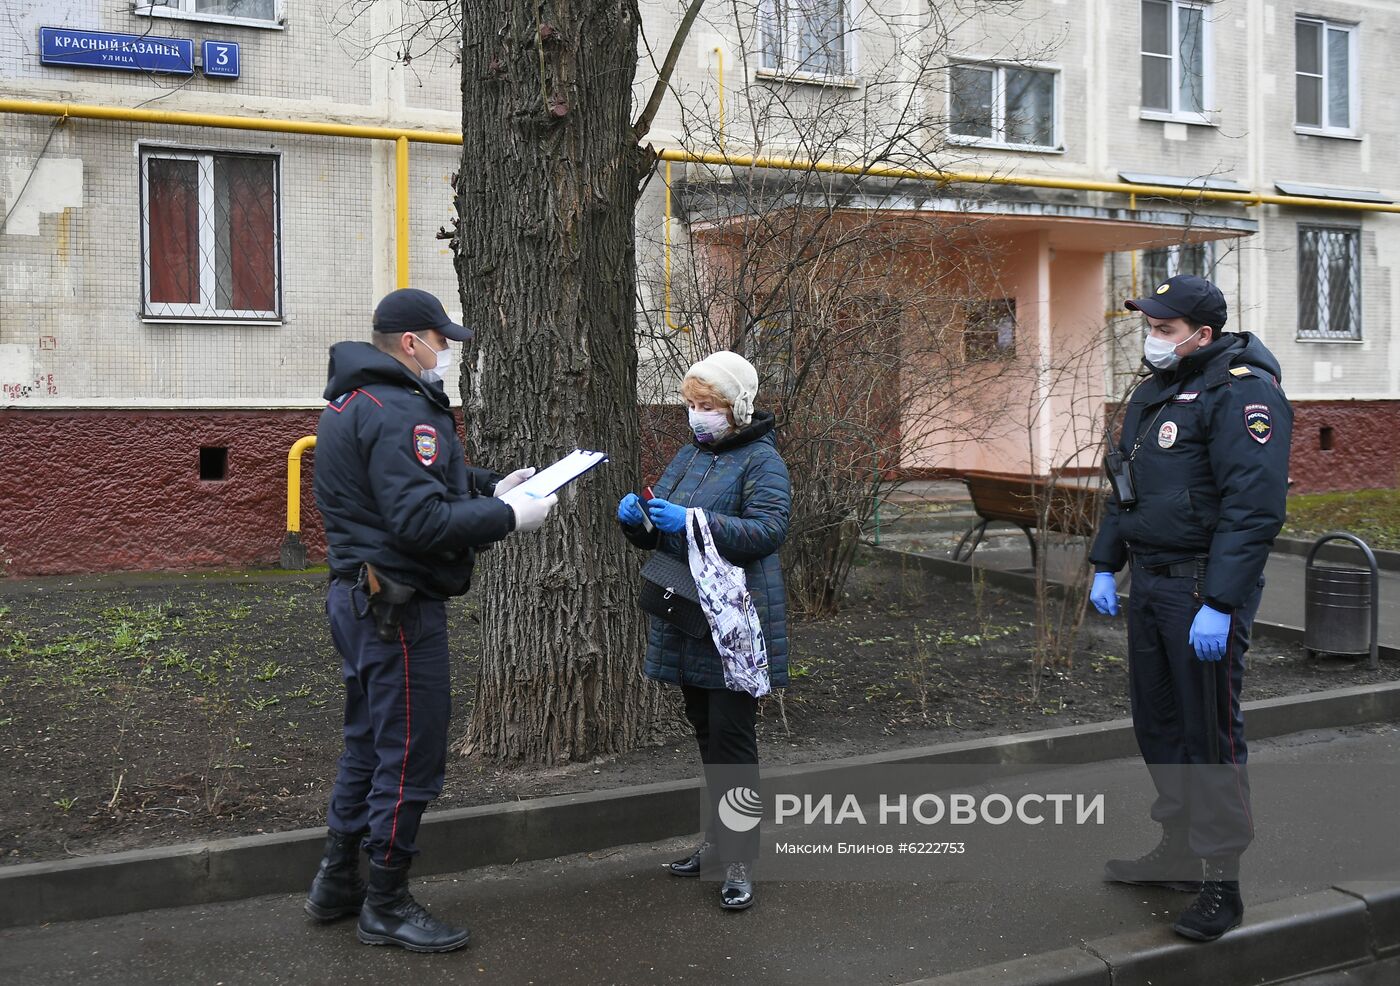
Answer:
[{"xmin": 0, "ymin": 409, "xmax": 325, "ymax": 576}]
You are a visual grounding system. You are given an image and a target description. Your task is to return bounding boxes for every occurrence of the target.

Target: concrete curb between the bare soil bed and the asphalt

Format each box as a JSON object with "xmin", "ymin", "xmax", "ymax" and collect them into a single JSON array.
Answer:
[{"xmin": 0, "ymin": 682, "xmax": 1400, "ymax": 929}]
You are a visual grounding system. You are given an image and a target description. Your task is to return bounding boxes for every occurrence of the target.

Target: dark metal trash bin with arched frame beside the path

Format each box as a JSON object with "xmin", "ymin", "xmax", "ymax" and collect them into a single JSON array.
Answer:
[{"xmin": 1303, "ymin": 531, "xmax": 1380, "ymax": 668}]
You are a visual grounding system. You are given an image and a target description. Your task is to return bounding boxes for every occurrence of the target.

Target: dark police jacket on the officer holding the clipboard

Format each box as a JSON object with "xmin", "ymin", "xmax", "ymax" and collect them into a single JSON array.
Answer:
[{"xmin": 315, "ymin": 342, "xmax": 515, "ymax": 599}]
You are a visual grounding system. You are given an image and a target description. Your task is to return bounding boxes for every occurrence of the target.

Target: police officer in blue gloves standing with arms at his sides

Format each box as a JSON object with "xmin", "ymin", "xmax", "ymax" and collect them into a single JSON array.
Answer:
[{"xmin": 1089, "ymin": 275, "xmax": 1292, "ymax": 941}]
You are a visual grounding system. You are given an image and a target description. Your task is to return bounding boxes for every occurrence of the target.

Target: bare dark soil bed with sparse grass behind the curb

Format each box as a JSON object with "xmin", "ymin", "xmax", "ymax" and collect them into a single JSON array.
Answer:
[{"xmin": 0, "ymin": 552, "xmax": 1383, "ymax": 864}]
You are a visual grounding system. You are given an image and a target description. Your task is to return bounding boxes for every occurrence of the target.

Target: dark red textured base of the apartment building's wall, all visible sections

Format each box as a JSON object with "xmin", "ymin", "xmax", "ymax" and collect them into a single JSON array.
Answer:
[{"xmin": 0, "ymin": 401, "xmax": 1400, "ymax": 576}]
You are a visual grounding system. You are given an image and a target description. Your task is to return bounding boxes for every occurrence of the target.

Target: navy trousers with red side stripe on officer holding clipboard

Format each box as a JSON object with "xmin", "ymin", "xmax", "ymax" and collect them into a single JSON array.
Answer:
[{"xmin": 326, "ymin": 578, "xmax": 452, "ymax": 866}]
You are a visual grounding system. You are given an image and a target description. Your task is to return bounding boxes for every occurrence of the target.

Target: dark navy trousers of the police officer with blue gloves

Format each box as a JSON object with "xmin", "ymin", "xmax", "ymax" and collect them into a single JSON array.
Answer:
[{"xmin": 1128, "ymin": 563, "xmax": 1263, "ymax": 859}]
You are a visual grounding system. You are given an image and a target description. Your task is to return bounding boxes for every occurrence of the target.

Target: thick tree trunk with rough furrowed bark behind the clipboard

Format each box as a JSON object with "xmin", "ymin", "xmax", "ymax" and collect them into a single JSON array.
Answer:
[{"xmin": 456, "ymin": 0, "xmax": 664, "ymax": 763}]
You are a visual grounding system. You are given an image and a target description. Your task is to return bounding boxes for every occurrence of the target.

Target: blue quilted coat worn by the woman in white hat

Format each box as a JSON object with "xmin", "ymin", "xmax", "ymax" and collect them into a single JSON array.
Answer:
[{"xmin": 622, "ymin": 410, "xmax": 792, "ymax": 688}]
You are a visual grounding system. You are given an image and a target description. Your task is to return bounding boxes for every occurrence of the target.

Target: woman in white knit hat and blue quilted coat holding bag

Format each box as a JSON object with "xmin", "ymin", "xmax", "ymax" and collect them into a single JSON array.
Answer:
[{"xmin": 617, "ymin": 352, "xmax": 792, "ymax": 910}]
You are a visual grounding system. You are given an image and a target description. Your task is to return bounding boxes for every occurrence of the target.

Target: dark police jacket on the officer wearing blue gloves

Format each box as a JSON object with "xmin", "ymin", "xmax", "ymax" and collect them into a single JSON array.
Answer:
[{"xmin": 1089, "ymin": 332, "xmax": 1294, "ymax": 612}]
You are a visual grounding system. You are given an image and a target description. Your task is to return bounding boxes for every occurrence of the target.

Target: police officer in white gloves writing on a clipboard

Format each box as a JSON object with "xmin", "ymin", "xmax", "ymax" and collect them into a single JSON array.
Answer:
[{"xmin": 305, "ymin": 289, "xmax": 556, "ymax": 952}]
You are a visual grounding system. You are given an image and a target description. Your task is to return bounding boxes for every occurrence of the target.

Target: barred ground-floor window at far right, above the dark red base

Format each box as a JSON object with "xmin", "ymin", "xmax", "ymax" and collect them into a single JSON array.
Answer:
[{"xmin": 1298, "ymin": 224, "xmax": 1361, "ymax": 340}]
